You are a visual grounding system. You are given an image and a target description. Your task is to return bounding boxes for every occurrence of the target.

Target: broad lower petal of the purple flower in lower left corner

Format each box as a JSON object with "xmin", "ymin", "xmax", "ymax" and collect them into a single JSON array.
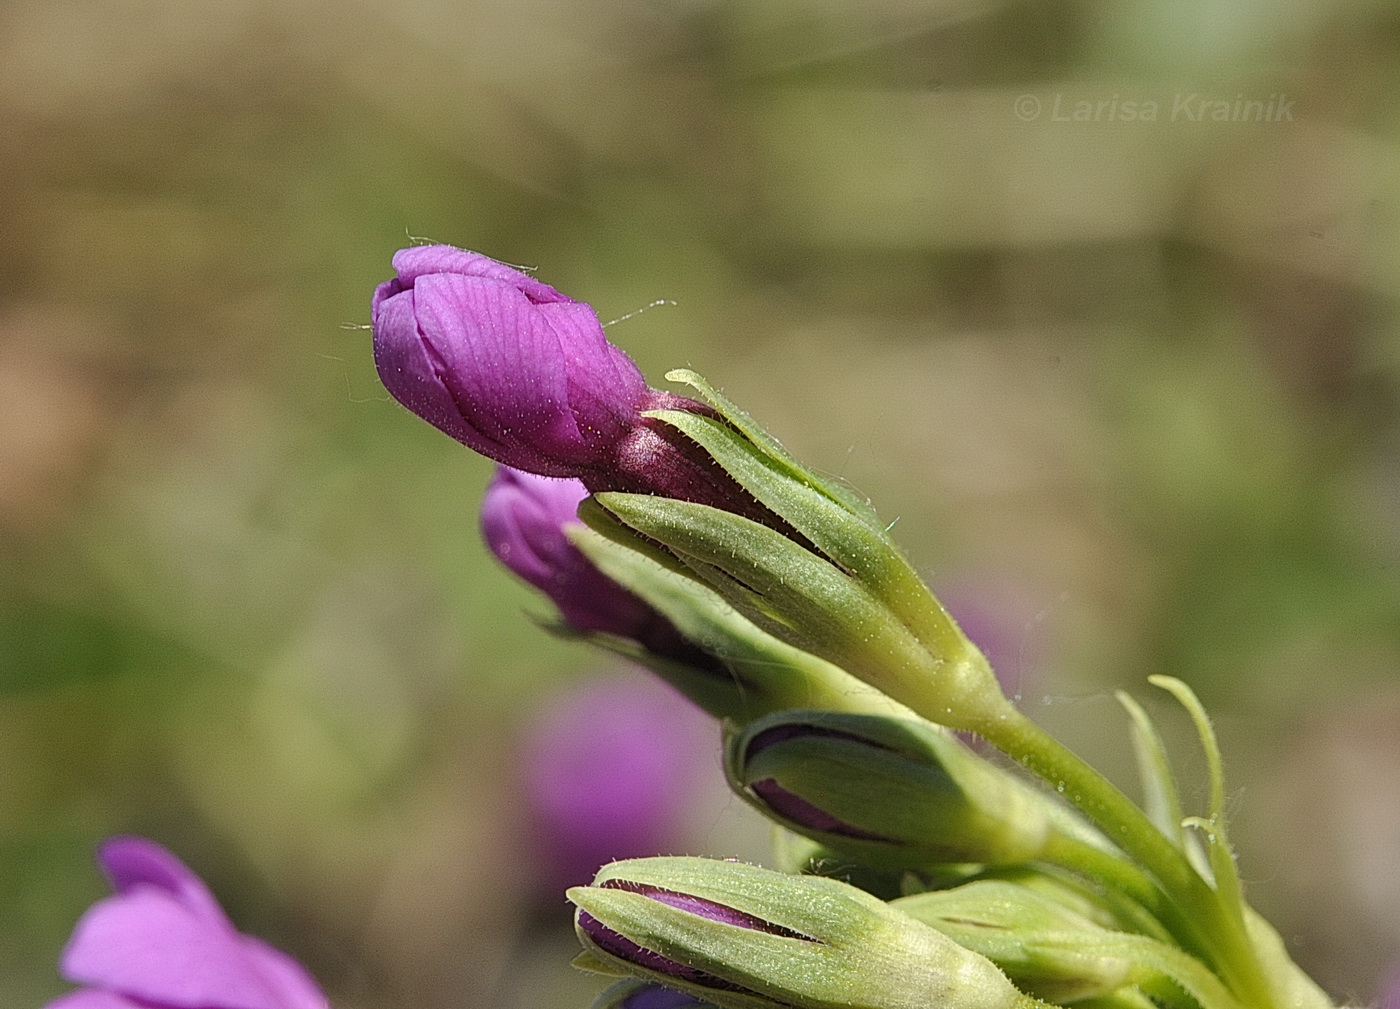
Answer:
[{"xmin": 62, "ymin": 886, "xmax": 288, "ymax": 1009}]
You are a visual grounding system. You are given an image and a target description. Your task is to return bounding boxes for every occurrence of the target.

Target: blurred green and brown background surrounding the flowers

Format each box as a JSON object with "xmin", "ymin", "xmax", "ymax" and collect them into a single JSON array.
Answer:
[{"xmin": 0, "ymin": 0, "xmax": 1400, "ymax": 1009}]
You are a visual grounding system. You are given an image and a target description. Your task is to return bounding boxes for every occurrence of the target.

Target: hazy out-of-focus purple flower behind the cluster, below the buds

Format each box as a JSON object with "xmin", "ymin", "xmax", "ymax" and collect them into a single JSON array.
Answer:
[{"xmin": 521, "ymin": 672, "xmax": 718, "ymax": 896}]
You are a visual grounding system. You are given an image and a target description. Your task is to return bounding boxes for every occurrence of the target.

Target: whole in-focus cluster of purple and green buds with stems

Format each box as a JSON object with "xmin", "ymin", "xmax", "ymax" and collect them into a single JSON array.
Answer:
[{"xmin": 361, "ymin": 246, "xmax": 1330, "ymax": 1009}]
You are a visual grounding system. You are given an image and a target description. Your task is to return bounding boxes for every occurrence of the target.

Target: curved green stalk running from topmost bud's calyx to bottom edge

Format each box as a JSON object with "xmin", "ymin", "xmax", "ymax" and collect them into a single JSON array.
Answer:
[{"xmin": 976, "ymin": 704, "xmax": 1274, "ymax": 1009}]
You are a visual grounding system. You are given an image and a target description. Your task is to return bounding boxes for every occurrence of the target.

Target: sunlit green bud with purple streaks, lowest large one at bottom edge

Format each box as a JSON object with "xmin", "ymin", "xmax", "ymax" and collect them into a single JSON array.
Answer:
[{"xmin": 568, "ymin": 858, "xmax": 1032, "ymax": 1009}]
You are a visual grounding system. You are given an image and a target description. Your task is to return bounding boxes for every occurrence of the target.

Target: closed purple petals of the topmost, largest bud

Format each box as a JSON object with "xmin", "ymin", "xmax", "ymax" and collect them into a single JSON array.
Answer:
[{"xmin": 371, "ymin": 245, "xmax": 647, "ymax": 476}]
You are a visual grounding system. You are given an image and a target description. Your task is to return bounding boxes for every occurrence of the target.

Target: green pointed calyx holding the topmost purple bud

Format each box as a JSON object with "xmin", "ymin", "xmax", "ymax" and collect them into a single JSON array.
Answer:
[{"xmin": 585, "ymin": 371, "xmax": 1009, "ymax": 732}]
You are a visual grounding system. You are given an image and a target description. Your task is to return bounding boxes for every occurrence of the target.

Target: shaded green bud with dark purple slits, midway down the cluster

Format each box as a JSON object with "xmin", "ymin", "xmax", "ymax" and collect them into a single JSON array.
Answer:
[{"xmin": 725, "ymin": 711, "xmax": 1057, "ymax": 869}]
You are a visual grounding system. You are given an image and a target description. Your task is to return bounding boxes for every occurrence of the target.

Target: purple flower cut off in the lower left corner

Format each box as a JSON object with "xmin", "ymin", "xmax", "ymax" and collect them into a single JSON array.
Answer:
[{"xmin": 48, "ymin": 837, "xmax": 328, "ymax": 1009}]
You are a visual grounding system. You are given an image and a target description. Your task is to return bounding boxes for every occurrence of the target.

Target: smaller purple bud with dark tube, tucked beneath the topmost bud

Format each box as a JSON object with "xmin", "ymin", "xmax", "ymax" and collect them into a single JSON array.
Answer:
[{"xmin": 482, "ymin": 466, "xmax": 725, "ymax": 676}]
